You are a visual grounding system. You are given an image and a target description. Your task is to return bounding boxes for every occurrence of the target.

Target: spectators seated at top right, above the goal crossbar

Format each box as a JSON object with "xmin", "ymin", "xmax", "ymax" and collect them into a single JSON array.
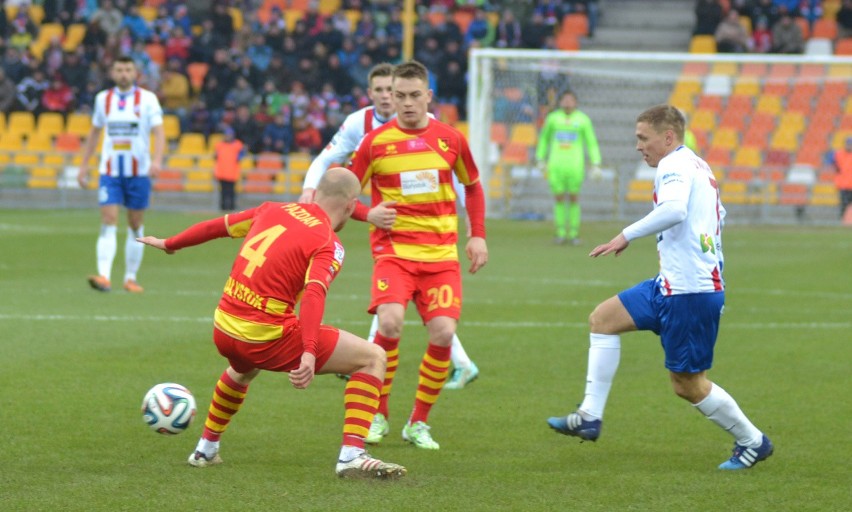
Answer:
[{"xmin": 693, "ymin": 0, "xmax": 852, "ymax": 54}]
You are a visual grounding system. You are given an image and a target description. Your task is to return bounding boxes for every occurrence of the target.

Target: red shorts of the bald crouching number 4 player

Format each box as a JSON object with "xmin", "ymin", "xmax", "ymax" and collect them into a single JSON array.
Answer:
[{"xmin": 213, "ymin": 319, "xmax": 340, "ymax": 373}]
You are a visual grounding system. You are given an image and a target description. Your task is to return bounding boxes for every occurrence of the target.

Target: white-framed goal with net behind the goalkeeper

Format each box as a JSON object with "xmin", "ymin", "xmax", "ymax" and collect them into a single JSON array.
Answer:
[{"xmin": 468, "ymin": 49, "xmax": 852, "ymax": 222}]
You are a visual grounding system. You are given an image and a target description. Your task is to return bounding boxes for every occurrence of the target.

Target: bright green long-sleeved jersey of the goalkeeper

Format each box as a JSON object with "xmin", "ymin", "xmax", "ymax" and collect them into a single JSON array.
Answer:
[{"xmin": 535, "ymin": 109, "xmax": 601, "ymax": 171}]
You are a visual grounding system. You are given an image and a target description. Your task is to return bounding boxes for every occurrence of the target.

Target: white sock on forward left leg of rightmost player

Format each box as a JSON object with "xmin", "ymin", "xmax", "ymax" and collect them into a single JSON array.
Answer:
[{"xmin": 580, "ymin": 333, "xmax": 621, "ymax": 420}]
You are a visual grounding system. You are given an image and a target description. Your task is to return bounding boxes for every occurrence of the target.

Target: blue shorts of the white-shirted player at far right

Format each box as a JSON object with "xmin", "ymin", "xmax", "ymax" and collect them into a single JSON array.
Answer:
[{"xmin": 618, "ymin": 279, "xmax": 725, "ymax": 373}]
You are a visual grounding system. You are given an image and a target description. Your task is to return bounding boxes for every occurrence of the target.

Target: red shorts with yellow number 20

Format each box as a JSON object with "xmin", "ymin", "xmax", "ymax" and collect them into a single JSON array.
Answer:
[{"xmin": 368, "ymin": 258, "xmax": 461, "ymax": 323}]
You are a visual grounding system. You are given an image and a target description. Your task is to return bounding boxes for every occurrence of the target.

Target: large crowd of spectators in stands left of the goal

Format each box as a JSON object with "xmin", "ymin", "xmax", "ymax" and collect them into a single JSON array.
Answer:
[{"xmin": 0, "ymin": 0, "xmax": 597, "ymax": 153}]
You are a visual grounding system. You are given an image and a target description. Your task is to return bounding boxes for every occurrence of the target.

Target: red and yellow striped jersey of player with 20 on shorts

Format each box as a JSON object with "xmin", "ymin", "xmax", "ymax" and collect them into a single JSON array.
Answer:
[{"xmin": 350, "ymin": 118, "xmax": 479, "ymax": 262}]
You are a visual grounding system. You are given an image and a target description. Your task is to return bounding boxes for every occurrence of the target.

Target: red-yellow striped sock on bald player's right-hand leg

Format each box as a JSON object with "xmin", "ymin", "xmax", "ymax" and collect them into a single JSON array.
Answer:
[{"xmin": 343, "ymin": 372, "xmax": 382, "ymax": 448}]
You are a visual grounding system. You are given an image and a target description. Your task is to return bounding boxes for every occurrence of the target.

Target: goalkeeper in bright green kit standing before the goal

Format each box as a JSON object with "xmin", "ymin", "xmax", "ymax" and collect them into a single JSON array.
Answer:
[{"xmin": 535, "ymin": 91, "xmax": 601, "ymax": 245}]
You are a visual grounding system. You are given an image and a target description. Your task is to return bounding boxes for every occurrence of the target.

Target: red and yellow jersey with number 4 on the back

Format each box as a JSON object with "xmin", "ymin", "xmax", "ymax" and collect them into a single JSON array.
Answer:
[{"xmin": 171, "ymin": 202, "xmax": 344, "ymax": 343}]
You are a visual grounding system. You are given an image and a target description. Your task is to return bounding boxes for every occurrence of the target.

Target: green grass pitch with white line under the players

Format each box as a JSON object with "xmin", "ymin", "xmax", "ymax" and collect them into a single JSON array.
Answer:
[{"xmin": 0, "ymin": 209, "xmax": 852, "ymax": 512}]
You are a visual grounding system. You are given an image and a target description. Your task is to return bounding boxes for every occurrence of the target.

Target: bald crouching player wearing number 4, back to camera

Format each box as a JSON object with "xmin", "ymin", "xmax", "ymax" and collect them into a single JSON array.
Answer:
[{"xmin": 139, "ymin": 168, "xmax": 406, "ymax": 478}]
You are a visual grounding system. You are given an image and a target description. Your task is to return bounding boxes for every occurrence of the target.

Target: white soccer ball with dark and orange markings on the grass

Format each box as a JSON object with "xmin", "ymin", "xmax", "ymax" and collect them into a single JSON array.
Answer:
[{"xmin": 142, "ymin": 382, "xmax": 196, "ymax": 435}]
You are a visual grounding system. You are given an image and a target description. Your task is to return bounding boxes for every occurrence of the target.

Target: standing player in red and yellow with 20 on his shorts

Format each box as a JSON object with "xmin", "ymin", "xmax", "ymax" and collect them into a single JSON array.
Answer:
[{"xmin": 351, "ymin": 61, "xmax": 488, "ymax": 450}]
